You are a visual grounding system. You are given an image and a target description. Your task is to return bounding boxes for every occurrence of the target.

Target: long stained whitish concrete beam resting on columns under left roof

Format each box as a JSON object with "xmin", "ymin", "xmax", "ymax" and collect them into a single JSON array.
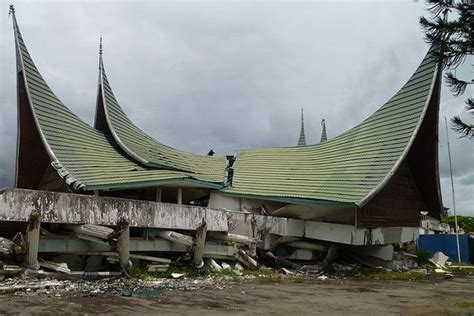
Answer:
[{"xmin": 0, "ymin": 189, "xmax": 228, "ymax": 232}]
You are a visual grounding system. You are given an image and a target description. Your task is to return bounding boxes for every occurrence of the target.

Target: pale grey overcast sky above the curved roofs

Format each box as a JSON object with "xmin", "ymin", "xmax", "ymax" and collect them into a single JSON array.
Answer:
[{"xmin": 0, "ymin": 0, "xmax": 474, "ymax": 215}]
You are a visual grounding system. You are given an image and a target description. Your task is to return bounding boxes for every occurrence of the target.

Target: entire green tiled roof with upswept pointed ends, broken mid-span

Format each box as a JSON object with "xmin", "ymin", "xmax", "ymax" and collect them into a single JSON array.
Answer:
[{"xmin": 14, "ymin": 9, "xmax": 439, "ymax": 206}]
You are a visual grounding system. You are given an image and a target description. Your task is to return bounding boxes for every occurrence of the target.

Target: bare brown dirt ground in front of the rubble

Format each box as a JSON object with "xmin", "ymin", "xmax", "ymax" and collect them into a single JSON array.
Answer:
[{"xmin": 0, "ymin": 276, "xmax": 474, "ymax": 315}]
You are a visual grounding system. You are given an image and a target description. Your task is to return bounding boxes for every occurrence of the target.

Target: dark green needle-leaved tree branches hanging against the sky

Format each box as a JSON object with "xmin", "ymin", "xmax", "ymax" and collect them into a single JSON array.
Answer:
[{"xmin": 420, "ymin": 0, "xmax": 474, "ymax": 139}]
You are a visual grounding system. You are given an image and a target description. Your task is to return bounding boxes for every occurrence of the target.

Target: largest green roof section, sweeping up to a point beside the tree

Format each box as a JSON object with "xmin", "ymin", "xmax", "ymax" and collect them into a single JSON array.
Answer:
[{"xmin": 224, "ymin": 52, "xmax": 438, "ymax": 206}]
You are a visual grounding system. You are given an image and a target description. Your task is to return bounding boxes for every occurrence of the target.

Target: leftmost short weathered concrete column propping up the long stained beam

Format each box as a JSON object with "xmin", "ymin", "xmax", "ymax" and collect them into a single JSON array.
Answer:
[{"xmin": 24, "ymin": 210, "xmax": 41, "ymax": 270}]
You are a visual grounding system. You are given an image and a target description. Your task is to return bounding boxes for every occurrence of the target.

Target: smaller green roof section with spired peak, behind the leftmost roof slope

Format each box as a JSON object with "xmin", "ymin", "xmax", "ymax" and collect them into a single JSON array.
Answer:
[{"xmin": 97, "ymin": 59, "xmax": 227, "ymax": 183}]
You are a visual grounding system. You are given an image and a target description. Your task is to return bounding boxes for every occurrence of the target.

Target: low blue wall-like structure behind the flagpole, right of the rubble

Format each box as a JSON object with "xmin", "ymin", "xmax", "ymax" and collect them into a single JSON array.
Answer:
[{"xmin": 418, "ymin": 234, "xmax": 472, "ymax": 263}]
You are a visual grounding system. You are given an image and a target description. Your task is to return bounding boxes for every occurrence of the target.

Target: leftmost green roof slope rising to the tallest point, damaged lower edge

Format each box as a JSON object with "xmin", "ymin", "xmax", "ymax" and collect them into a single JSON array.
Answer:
[{"xmin": 13, "ymin": 12, "xmax": 220, "ymax": 190}]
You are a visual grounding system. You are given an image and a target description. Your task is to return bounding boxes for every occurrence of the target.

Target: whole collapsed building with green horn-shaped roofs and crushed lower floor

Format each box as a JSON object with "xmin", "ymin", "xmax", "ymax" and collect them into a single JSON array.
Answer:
[{"xmin": 0, "ymin": 8, "xmax": 443, "ymax": 274}]
